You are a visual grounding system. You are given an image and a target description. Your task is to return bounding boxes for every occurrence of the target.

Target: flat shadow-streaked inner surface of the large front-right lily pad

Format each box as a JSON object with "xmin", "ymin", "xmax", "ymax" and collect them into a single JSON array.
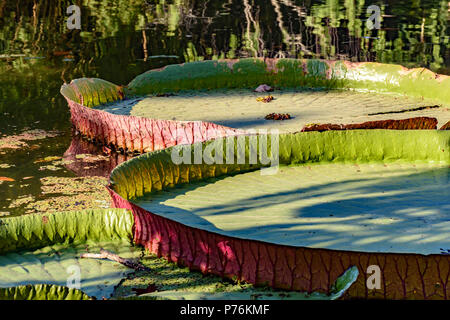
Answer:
[{"xmin": 134, "ymin": 163, "xmax": 450, "ymax": 254}]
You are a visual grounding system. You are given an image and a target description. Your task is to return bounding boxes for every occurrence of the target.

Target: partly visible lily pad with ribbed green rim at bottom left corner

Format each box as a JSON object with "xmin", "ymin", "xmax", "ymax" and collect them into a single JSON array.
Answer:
[{"xmin": 0, "ymin": 209, "xmax": 137, "ymax": 299}]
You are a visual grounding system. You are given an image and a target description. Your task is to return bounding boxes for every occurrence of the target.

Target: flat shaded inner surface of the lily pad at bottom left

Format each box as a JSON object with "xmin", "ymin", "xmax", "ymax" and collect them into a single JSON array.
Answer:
[{"xmin": 0, "ymin": 242, "xmax": 141, "ymax": 299}]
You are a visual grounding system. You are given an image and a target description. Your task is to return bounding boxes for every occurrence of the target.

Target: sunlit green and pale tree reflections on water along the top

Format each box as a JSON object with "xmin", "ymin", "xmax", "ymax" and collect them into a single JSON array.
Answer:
[{"xmin": 0, "ymin": 0, "xmax": 450, "ymax": 74}]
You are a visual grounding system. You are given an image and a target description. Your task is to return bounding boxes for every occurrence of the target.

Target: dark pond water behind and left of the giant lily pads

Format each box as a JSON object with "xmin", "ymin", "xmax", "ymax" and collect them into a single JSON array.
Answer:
[{"xmin": 0, "ymin": 0, "xmax": 450, "ymax": 214}]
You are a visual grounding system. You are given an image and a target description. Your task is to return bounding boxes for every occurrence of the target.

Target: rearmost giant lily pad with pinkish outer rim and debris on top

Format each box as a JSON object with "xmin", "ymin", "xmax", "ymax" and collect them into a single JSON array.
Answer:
[{"xmin": 61, "ymin": 59, "xmax": 450, "ymax": 153}]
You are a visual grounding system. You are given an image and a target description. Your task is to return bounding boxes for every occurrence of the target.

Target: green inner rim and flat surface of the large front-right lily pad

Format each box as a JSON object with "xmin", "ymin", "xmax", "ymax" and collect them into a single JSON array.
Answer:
[{"xmin": 112, "ymin": 130, "xmax": 450, "ymax": 254}]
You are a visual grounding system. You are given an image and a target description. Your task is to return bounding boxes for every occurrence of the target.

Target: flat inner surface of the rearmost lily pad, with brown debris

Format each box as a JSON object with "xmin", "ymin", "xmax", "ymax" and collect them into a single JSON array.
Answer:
[{"xmin": 98, "ymin": 89, "xmax": 450, "ymax": 132}]
